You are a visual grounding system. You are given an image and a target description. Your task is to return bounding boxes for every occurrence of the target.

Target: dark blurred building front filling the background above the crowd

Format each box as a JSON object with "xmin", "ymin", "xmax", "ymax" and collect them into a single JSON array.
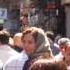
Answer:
[{"xmin": 0, "ymin": 0, "xmax": 70, "ymax": 36}]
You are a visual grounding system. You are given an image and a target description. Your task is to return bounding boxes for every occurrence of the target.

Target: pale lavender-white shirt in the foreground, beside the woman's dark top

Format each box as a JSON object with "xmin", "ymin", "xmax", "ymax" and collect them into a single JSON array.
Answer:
[{"xmin": 3, "ymin": 51, "xmax": 28, "ymax": 70}]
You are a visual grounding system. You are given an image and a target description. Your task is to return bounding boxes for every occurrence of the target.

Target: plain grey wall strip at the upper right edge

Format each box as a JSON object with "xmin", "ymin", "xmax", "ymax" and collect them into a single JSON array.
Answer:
[{"xmin": 61, "ymin": 0, "xmax": 70, "ymax": 38}]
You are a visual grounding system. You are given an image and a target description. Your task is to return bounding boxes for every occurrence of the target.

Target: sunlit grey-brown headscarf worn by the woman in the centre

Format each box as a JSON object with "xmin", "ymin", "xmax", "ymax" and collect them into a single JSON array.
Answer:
[{"xmin": 26, "ymin": 27, "xmax": 52, "ymax": 58}]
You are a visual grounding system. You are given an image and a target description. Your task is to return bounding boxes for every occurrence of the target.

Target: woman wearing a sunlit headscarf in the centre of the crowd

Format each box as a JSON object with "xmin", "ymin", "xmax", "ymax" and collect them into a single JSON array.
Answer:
[{"xmin": 21, "ymin": 27, "xmax": 52, "ymax": 70}]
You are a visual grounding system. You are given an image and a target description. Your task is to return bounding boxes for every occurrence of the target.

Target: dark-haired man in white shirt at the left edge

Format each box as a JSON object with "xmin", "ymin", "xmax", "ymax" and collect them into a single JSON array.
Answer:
[{"xmin": 0, "ymin": 30, "xmax": 18, "ymax": 69}]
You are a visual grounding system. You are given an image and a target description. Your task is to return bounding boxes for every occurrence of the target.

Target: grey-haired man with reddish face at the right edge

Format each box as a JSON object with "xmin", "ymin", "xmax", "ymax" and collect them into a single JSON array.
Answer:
[{"xmin": 56, "ymin": 38, "xmax": 70, "ymax": 67}]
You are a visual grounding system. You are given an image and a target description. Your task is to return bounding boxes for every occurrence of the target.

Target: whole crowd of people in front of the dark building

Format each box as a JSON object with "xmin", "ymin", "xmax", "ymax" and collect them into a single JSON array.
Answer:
[{"xmin": 0, "ymin": 27, "xmax": 70, "ymax": 70}]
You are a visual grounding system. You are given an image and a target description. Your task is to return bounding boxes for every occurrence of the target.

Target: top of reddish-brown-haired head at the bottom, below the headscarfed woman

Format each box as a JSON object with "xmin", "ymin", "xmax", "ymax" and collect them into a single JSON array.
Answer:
[{"xmin": 29, "ymin": 59, "xmax": 67, "ymax": 70}]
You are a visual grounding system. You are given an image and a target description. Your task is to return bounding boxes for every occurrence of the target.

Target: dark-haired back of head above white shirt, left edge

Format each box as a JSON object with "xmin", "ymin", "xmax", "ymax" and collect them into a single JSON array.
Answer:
[{"xmin": 0, "ymin": 30, "xmax": 10, "ymax": 44}]
